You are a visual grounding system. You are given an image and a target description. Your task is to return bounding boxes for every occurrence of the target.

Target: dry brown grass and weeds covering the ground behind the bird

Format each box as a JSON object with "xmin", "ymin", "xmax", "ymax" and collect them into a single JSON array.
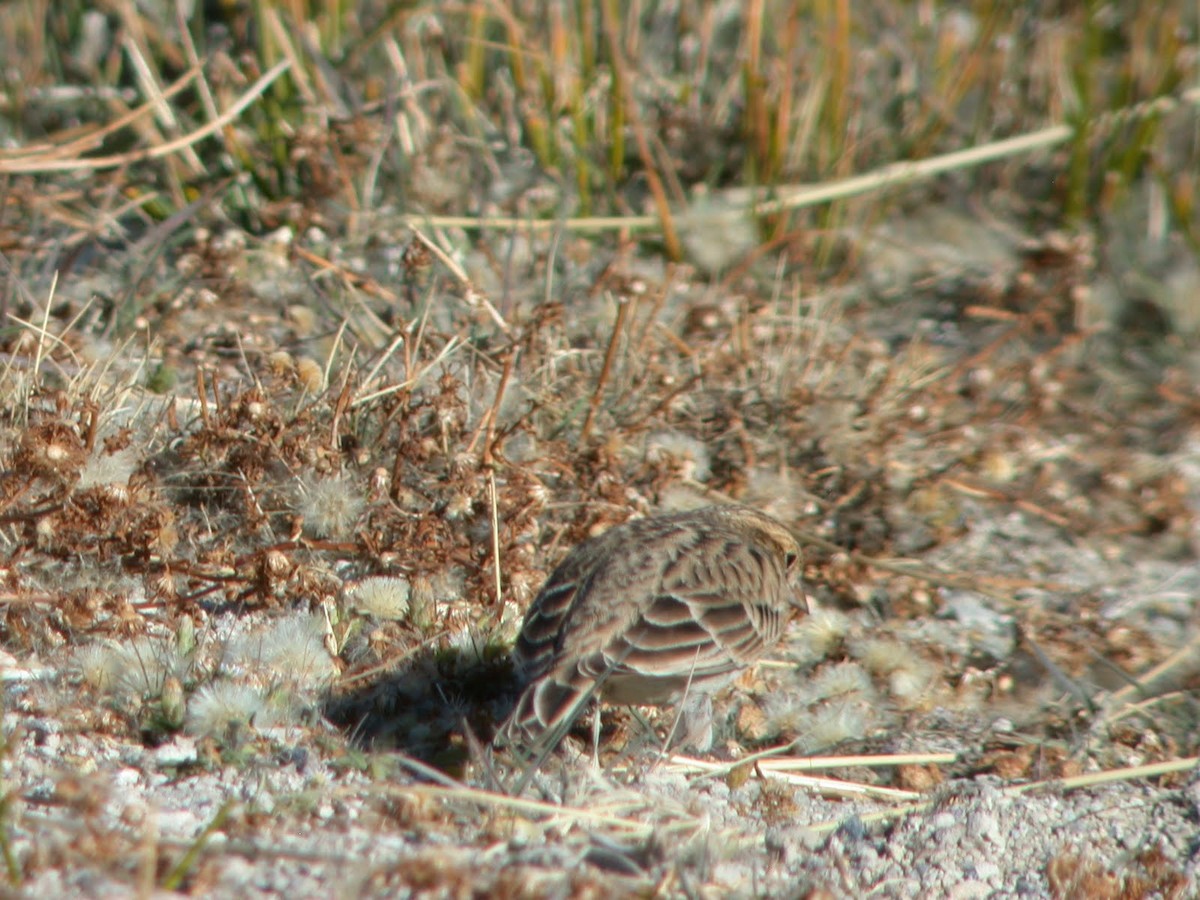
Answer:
[{"xmin": 0, "ymin": 0, "xmax": 1200, "ymax": 893}]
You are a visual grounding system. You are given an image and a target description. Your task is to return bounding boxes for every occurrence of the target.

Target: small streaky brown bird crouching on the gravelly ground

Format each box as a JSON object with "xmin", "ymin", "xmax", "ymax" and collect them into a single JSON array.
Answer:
[{"xmin": 494, "ymin": 506, "xmax": 804, "ymax": 750}]
